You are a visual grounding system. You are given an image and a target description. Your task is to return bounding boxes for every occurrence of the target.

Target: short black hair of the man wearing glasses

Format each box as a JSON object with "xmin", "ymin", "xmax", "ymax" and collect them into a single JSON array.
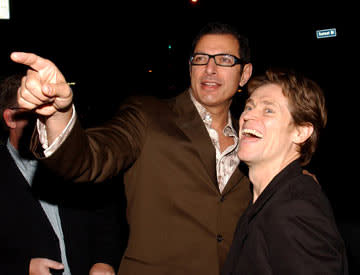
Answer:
[{"xmin": 191, "ymin": 22, "xmax": 250, "ymax": 63}]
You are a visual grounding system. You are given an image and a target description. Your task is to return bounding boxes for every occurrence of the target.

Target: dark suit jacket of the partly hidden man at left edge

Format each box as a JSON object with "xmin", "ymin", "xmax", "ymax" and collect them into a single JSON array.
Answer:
[{"xmin": 0, "ymin": 145, "xmax": 121, "ymax": 275}]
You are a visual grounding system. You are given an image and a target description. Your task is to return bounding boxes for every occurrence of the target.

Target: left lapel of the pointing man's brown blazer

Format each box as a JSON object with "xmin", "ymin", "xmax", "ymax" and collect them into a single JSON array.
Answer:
[{"xmin": 174, "ymin": 92, "xmax": 218, "ymax": 190}]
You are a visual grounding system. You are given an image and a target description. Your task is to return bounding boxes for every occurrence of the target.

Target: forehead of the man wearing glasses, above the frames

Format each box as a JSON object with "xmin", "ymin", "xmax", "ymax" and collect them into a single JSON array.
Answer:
[{"xmin": 195, "ymin": 34, "xmax": 239, "ymax": 55}]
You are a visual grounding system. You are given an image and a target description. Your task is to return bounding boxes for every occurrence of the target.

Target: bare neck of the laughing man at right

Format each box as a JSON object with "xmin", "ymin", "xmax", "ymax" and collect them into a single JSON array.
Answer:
[{"xmin": 248, "ymin": 154, "xmax": 299, "ymax": 203}]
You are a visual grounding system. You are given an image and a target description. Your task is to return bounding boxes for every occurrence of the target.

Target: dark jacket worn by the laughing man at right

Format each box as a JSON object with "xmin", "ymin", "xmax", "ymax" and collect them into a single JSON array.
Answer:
[{"xmin": 222, "ymin": 161, "xmax": 348, "ymax": 275}]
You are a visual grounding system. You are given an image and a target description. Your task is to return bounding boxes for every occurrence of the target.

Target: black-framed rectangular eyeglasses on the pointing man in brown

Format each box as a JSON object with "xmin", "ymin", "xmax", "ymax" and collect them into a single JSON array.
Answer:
[{"xmin": 190, "ymin": 53, "xmax": 245, "ymax": 67}]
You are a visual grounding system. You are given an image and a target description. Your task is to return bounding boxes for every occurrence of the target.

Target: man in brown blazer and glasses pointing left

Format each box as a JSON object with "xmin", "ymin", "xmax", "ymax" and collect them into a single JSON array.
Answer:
[{"xmin": 11, "ymin": 24, "xmax": 252, "ymax": 275}]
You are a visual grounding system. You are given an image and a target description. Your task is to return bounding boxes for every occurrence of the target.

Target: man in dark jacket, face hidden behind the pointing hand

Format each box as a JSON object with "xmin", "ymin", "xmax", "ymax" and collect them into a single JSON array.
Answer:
[{"xmin": 0, "ymin": 75, "xmax": 121, "ymax": 275}]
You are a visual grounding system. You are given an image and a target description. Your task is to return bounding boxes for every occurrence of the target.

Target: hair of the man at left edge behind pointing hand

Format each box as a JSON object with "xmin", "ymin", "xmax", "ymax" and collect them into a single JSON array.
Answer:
[{"xmin": 0, "ymin": 74, "xmax": 23, "ymax": 132}]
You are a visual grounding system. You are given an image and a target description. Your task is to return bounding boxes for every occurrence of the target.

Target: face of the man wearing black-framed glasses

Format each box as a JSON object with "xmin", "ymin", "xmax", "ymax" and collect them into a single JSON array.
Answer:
[{"xmin": 190, "ymin": 34, "xmax": 251, "ymax": 111}]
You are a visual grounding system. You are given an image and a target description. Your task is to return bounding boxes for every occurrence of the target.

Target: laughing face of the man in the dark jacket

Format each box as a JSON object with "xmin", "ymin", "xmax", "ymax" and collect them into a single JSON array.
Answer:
[{"xmin": 238, "ymin": 84, "xmax": 301, "ymax": 168}]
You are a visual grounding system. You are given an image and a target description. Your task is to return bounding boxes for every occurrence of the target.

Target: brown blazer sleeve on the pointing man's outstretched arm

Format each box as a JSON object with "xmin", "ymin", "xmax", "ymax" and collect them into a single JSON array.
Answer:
[{"xmin": 31, "ymin": 97, "xmax": 147, "ymax": 182}]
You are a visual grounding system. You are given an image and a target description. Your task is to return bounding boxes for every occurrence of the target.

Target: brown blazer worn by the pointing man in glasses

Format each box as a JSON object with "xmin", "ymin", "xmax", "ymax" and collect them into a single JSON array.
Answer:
[{"xmin": 33, "ymin": 92, "xmax": 251, "ymax": 275}]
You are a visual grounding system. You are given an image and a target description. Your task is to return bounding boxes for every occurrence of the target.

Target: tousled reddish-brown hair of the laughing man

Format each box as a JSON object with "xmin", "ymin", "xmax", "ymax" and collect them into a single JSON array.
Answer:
[{"xmin": 248, "ymin": 69, "xmax": 327, "ymax": 165}]
